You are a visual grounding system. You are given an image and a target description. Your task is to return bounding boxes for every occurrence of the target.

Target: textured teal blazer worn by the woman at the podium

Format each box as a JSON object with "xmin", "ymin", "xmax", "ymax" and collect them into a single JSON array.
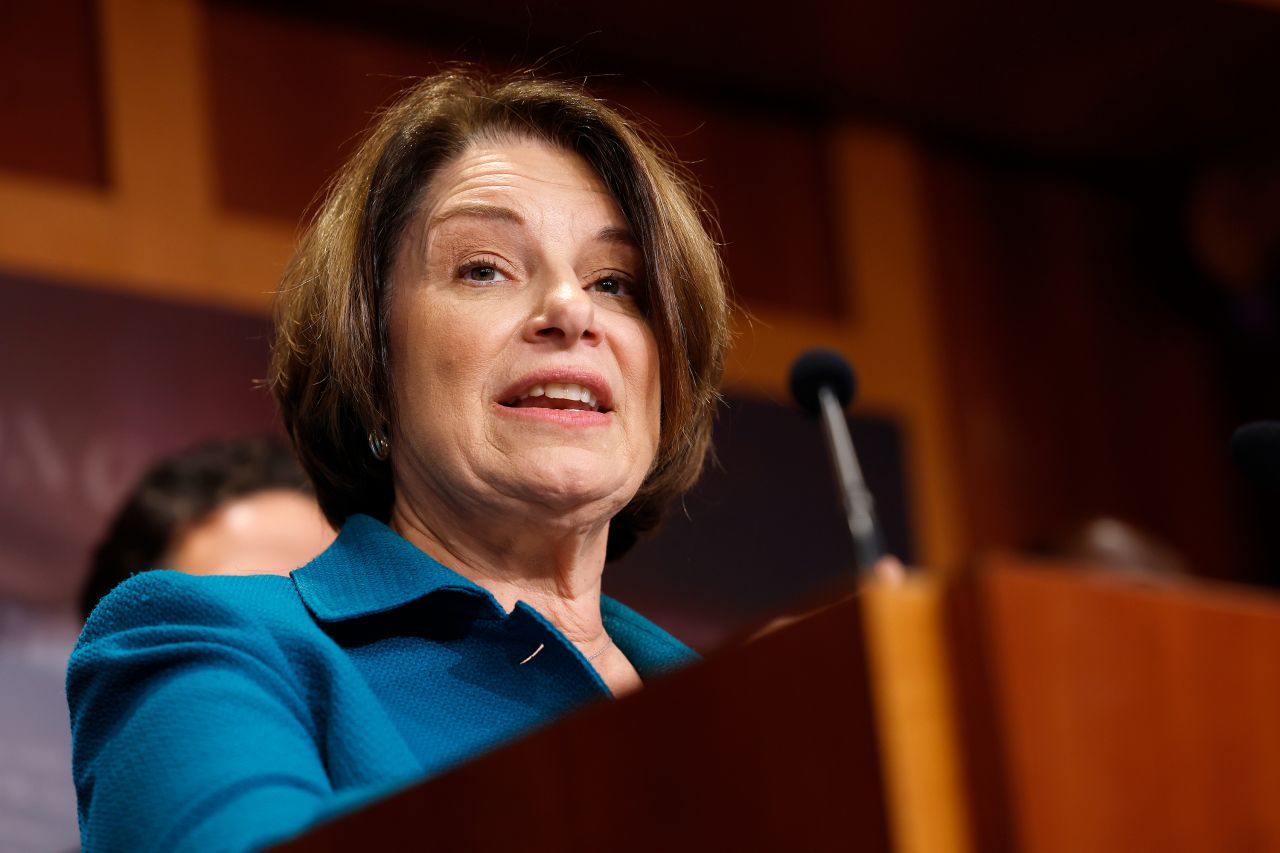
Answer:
[{"xmin": 67, "ymin": 516, "xmax": 696, "ymax": 853}]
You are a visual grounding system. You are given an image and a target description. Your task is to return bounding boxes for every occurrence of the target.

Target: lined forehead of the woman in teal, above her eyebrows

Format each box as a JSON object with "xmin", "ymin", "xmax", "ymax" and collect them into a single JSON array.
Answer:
[{"xmin": 421, "ymin": 137, "xmax": 626, "ymax": 228}]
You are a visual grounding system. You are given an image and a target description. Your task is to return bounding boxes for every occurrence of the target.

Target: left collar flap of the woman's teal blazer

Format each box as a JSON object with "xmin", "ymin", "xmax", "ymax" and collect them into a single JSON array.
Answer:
[{"xmin": 291, "ymin": 515, "xmax": 503, "ymax": 622}]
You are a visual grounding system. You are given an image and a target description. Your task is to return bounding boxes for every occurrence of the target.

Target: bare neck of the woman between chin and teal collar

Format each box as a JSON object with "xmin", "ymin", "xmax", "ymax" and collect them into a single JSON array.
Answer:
[{"xmin": 390, "ymin": 496, "xmax": 609, "ymax": 640}]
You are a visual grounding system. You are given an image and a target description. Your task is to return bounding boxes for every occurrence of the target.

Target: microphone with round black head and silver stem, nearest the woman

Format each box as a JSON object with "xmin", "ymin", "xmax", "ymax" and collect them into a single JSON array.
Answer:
[{"xmin": 791, "ymin": 350, "xmax": 884, "ymax": 573}]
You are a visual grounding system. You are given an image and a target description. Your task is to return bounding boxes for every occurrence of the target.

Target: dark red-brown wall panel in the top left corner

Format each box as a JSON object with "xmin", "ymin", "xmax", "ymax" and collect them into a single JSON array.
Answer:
[{"xmin": 0, "ymin": 0, "xmax": 106, "ymax": 184}]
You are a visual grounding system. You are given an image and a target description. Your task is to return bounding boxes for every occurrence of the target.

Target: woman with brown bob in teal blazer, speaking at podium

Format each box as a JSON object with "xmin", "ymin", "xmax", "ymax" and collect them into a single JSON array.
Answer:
[{"xmin": 68, "ymin": 73, "xmax": 727, "ymax": 850}]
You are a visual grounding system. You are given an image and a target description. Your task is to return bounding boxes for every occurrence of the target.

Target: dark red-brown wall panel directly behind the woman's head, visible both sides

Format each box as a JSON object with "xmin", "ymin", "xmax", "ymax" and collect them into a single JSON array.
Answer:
[{"xmin": 206, "ymin": 3, "xmax": 846, "ymax": 319}]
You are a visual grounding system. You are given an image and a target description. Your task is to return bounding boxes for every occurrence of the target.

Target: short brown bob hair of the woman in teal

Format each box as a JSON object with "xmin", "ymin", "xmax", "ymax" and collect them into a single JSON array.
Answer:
[{"xmin": 268, "ymin": 68, "xmax": 728, "ymax": 558}]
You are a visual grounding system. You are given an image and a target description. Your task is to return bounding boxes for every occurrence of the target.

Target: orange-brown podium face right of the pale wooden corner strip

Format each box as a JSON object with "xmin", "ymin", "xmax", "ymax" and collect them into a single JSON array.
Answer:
[{"xmin": 948, "ymin": 557, "xmax": 1280, "ymax": 852}]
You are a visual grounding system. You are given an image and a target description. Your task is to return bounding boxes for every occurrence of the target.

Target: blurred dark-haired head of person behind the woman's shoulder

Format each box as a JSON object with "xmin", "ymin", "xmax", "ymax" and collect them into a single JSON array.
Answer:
[{"xmin": 79, "ymin": 438, "xmax": 335, "ymax": 619}]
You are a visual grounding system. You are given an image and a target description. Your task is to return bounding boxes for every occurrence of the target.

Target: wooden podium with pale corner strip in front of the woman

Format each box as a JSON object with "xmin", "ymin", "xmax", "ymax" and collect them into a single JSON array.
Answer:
[{"xmin": 274, "ymin": 557, "xmax": 1280, "ymax": 853}]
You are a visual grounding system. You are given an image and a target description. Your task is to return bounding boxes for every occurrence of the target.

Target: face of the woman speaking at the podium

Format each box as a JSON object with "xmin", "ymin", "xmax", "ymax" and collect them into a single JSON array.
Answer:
[{"xmin": 388, "ymin": 138, "xmax": 660, "ymax": 525}]
